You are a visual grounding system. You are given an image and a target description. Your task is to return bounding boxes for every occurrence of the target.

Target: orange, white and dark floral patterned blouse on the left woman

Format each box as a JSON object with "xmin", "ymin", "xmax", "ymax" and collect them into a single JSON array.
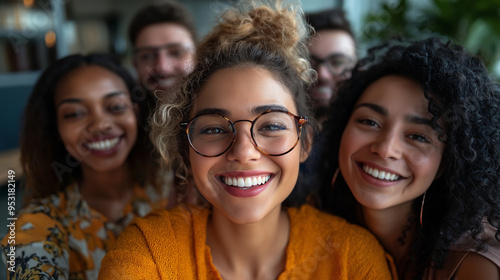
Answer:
[{"xmin": 1, "ymin": 185, "xmax": 166, "ymax": 280}]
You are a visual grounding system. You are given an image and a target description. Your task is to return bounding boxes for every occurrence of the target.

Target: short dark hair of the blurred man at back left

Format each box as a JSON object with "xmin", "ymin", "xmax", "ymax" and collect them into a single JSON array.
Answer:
[{"xmin": 128, "ymin": 1, "xmax": 196, "ymax": 46}]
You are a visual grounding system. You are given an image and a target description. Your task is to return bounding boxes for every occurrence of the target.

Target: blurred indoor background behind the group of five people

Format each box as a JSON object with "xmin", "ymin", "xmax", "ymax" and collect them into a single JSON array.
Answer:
[{"xmin": 0, "ymin": 0, "xmax": 500, "ymax": 280}]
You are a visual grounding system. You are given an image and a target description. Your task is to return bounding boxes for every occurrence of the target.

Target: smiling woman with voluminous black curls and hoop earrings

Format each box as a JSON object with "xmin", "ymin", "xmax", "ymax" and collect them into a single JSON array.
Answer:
[{"xmin": 316, "ymin": 38, "xmax": 500, "ymax": 279}]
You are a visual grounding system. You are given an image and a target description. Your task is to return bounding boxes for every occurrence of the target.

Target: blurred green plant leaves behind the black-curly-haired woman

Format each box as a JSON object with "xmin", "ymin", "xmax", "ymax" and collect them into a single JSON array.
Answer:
[{"xmin": 361, "ymin": 0, "xmax": 500, "ymax": 77}]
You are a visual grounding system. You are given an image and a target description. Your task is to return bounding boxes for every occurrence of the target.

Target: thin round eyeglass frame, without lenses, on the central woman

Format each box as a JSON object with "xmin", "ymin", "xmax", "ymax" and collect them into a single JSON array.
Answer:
[{"xmin": 179, "ymin": 109, "xmax": 308, "ymax": 157}]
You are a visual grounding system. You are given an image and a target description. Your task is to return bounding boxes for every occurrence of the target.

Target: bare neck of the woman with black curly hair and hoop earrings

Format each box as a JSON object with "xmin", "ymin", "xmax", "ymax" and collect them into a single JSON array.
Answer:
[{"xmin": 361, "ymin": 201, "xmax": 415, "ymax": 266}]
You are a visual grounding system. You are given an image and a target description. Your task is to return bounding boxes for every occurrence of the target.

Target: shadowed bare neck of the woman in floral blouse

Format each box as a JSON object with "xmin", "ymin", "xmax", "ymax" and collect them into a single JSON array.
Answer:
[{"xmin": 80, "ymin": 164, "xmax": 134, "ymax": 221}]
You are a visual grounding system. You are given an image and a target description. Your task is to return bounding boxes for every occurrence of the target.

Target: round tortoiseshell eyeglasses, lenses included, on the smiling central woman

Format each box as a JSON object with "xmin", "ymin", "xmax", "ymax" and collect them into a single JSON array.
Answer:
[{"xmin": 180, "ymin": 110, "xmax": 307, "ymax": 157}]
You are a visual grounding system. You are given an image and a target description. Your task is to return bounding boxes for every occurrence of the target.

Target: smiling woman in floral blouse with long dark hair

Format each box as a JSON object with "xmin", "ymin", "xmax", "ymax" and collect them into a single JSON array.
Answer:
[{"xmin": 2, "ymin": 54, "xmax": 170, "ymax": 279}]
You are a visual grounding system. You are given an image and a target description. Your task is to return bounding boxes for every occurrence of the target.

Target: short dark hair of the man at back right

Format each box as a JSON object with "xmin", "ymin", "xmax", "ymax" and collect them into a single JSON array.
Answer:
[{"xmin": 305, "ymin": 8, "xmax": 355, "ymax": 38}]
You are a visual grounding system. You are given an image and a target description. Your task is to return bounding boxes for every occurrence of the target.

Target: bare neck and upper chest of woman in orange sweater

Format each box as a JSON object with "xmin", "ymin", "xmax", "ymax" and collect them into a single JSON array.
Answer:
[{"xmin": 207, "ymin": 207, "xmax": 290, "ymax": 279}]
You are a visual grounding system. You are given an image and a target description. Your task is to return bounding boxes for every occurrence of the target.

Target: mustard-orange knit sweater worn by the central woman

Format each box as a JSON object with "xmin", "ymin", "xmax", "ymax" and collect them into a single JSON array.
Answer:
[{"xmin": 99, "ymin": 205, "xmax": 391, "ymax": 280}]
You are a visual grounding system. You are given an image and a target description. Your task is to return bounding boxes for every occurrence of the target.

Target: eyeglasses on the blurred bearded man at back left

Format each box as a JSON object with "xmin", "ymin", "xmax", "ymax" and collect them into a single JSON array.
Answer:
[{"xmin": 134, "ymin": 44, "xmax": 194, "ymax": 65}]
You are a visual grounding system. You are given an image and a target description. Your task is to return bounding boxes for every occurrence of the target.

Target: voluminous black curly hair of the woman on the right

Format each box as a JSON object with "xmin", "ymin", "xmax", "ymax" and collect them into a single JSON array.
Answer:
[{"xmin": 315, "ymin": 38, "xmax": 500, "ymax": 274}]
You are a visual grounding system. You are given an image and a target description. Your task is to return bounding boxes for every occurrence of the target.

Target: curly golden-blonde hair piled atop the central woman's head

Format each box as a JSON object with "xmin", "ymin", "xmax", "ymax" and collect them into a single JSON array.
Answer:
[{"xmin": 197, "ymin": 0, "xmax": 316, "ymax": 84}]
